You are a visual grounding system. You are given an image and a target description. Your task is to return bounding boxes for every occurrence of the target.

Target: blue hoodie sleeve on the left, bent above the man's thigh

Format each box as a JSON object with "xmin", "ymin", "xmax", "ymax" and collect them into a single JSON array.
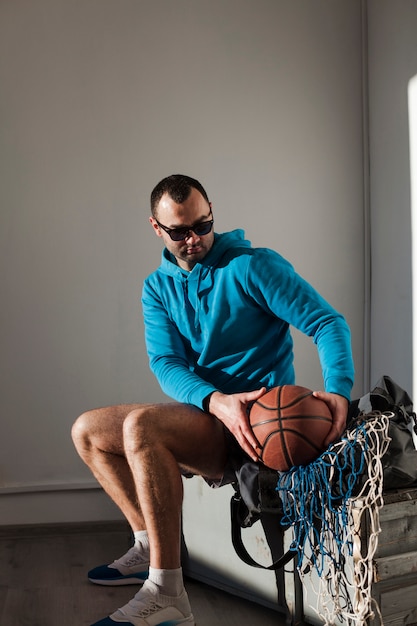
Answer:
[{"xmin": 142, "ymin": 281, "xmax": 216, "ymax": 409}]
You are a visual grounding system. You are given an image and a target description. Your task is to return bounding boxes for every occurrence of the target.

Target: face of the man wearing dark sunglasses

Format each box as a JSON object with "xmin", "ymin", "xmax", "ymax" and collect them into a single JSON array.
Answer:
[{"xmin": 149, "ymin": 187, "xmax": 214, "ymax": 271}]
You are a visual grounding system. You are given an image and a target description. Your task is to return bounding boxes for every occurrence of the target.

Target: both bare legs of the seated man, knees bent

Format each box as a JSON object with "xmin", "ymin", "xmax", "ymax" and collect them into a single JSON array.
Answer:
[{"xmin": 72, "ymin": 403, "xmax": 226, "ymax": 556}]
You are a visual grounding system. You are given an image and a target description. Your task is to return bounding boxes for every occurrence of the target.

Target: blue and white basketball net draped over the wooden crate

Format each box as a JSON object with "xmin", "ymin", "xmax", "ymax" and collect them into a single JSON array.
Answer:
[{"xmin": 277, "ymin": 412, "xmax": 392, "ymax": 626}]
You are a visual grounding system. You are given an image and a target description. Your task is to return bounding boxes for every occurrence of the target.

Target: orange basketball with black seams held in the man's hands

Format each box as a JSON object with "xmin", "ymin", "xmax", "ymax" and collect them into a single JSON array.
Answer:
[{"xmin": 249, "ymin": 385, "xmax": 332, "ymax": 472}]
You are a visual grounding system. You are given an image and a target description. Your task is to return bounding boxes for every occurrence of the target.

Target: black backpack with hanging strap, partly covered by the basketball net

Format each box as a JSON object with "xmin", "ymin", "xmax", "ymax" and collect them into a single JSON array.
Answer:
[{"xmin": 231, "ymin": 376, "xmax": 417, "ymax": 570}]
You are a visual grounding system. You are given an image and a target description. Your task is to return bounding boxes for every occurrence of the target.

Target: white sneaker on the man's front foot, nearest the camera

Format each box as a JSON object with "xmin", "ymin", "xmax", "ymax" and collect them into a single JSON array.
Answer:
[{"xmin": 92, "ymin": 580, "xmax": 195, "ymax": 626}]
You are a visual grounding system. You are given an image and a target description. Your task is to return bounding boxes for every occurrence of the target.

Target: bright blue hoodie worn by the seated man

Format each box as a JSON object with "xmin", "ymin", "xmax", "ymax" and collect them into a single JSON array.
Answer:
[{"xmin": 142, "ymin": 230, "xmax": 353, "ymax": 408}]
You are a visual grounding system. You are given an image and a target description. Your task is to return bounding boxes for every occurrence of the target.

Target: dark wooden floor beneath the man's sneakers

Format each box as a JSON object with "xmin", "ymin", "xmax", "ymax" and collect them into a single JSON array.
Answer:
[{"xmin": 0, "ymin": 524, "xmax": 285, "ymax": 626}]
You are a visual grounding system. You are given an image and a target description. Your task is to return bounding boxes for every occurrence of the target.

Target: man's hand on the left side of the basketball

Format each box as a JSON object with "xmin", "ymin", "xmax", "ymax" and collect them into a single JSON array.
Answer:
[{"xmin": 208, "ymin": 387, "xmax": 266, "ymax": 461}]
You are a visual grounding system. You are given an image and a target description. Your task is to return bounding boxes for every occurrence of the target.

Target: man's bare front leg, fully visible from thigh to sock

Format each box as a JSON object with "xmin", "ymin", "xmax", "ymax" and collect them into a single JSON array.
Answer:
[{"xmin": 124, "ymin": 404, "xmax": 226, "ymax": 569}]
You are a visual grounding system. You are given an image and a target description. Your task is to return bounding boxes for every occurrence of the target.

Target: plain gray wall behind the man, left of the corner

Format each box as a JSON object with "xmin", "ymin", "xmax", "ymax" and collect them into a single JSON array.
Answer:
[{"xmin": 0, "ymin": 0, "xmax": 366, "ymax": 524}]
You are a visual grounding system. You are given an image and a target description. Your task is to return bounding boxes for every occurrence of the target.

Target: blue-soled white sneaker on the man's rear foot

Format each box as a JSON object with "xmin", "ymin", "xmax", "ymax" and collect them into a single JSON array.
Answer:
[{"xmin": 88, "ymin": 546, "xmax": 149, "ymax": 586}]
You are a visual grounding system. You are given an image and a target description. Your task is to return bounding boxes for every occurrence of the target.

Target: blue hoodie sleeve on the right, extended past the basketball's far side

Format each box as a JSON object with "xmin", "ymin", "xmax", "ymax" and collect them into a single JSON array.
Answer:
[{"xmin": 247, "ymin": 249, "xmax": 354, "ymax": 399}]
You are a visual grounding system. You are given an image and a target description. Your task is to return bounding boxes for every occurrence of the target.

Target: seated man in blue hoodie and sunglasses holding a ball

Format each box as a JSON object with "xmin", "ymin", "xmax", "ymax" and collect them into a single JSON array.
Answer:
[{"xmin": 73, "ymin": 175, "xmax": 353, "ymax": 626}]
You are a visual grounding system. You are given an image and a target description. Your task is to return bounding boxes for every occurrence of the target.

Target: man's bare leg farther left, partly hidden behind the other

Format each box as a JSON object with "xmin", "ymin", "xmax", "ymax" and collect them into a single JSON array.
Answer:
[{"xmin": 72, "ymin": 404, "xmax": 145, "ymax": 531}]
